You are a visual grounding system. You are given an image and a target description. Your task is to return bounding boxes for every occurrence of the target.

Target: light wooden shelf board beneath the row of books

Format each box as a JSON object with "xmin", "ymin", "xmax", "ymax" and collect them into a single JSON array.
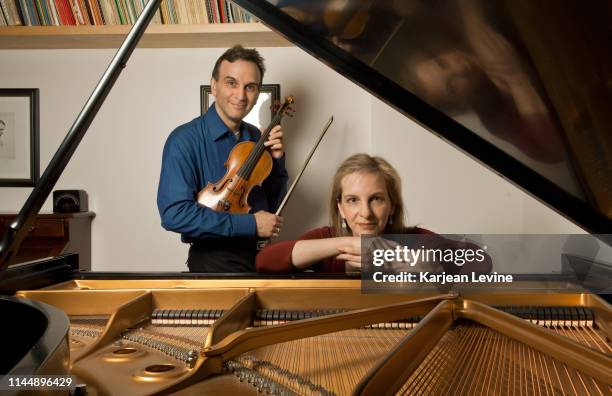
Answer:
[{"xmin": 0, "ymin": 23, "xmax": 292, "ymax": 49}]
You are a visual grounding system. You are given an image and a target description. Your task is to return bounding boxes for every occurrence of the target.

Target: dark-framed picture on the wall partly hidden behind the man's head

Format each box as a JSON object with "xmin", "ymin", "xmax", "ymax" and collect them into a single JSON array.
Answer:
[{"xmin": 200, "ymin": 84, "xmax": 280, "ymax": 128}]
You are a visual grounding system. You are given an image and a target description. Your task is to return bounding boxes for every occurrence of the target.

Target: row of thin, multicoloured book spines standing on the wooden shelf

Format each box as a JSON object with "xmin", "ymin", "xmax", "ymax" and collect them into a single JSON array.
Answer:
[{"xmin": 0, "ymin": 0, "xmax": 257, "ymax": 26}]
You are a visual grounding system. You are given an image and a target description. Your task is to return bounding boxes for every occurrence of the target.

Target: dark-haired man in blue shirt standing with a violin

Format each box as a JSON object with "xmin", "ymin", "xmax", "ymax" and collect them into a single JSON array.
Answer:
[{"xmin": 157, "ymin": 45, "xmax": 288, "ymax": 272}]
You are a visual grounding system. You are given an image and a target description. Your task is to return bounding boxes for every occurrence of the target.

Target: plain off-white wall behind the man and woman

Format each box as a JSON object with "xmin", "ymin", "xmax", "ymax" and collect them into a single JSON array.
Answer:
[{"xmin": 0, "ymin": 44, "xmax": 581, "ymax": 271}]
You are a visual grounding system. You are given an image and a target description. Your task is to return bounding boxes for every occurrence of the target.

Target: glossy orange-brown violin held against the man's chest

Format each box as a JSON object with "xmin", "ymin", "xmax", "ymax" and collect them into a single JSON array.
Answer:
[{"xmin": 196, "ymin": 95, "xmax": 293, "ymax": 213}]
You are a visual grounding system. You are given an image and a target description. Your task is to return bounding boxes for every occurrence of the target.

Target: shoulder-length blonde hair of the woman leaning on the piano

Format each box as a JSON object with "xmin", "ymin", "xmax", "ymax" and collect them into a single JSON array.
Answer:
[{"xmin": 329, "ymin": 153, "xmax": 405, "ymax": 236}]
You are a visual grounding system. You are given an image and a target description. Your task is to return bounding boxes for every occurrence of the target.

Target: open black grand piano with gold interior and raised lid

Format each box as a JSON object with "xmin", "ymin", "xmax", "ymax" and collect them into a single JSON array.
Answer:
[{"xmin": 0, "ymin": 0, "xmax": 612, "ymax": 395}]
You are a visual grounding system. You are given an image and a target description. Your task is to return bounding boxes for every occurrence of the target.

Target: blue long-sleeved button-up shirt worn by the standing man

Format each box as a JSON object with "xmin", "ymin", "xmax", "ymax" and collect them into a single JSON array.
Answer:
[{"xmin": 157, "ymin": 103, "xmax": 288, "ymax": 242}]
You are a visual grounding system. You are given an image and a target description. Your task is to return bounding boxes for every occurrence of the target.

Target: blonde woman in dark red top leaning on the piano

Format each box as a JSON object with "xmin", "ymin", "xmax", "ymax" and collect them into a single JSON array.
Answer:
[{"xmin": 256, "ymin": 154, "xmax": 491, "ymax": 273}]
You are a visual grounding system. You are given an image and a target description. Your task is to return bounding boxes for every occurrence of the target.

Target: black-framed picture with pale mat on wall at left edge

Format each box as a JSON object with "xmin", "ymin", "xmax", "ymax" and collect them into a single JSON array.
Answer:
[{"xmin": 0, "ymin": 88, "xmax": 40, "ymax": 187}]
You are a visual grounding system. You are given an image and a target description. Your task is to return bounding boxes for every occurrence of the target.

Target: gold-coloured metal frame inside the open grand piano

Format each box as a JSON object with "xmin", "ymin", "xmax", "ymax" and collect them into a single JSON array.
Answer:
[{"xmin": 17, "ymin": 279, "xmax": 612, "ymax": 395}]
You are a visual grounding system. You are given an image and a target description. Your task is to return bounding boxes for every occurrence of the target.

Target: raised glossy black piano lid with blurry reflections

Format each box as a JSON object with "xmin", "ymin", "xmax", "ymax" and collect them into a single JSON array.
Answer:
[{"xmin": 234, "ymin": 0, "xmax": 612, "ymax": 235}]
